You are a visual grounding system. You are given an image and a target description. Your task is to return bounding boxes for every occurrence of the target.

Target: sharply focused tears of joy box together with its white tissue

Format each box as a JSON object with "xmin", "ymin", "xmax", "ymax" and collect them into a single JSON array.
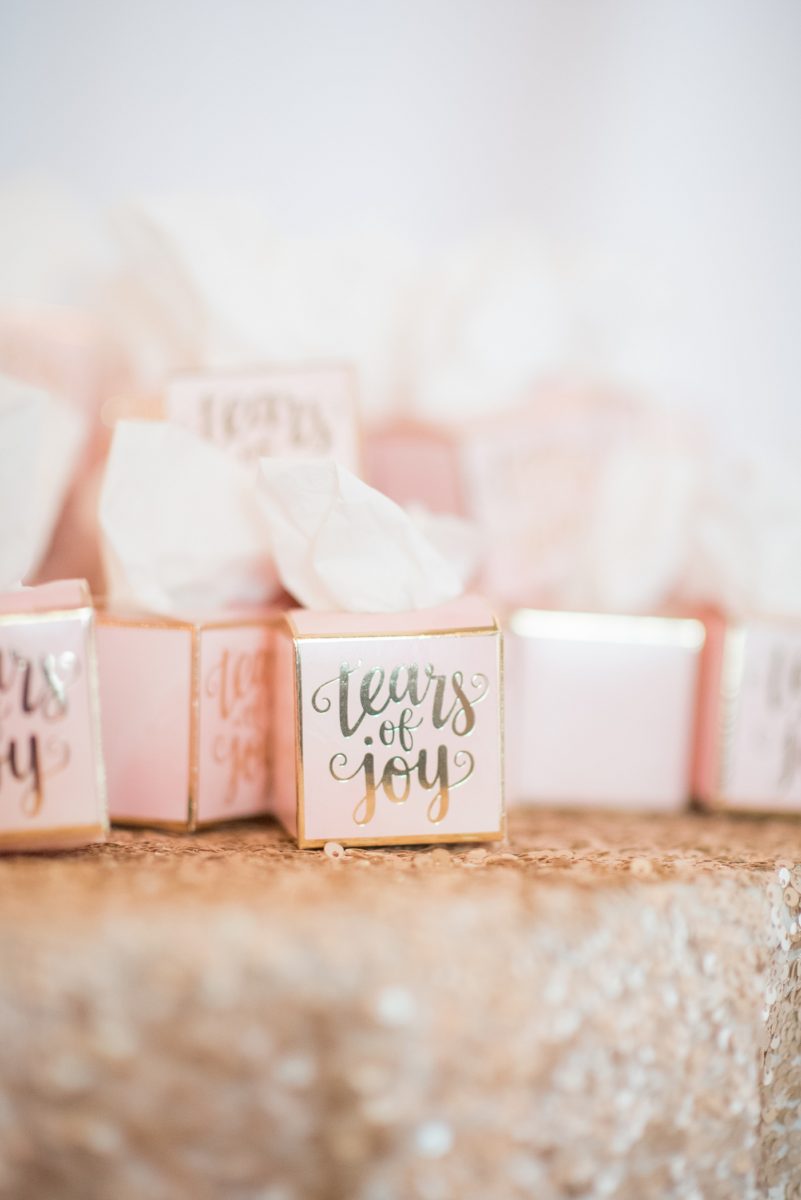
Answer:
[{"xmin": 261, "ymin": 460, "xmax": 504, "ymax": 846}]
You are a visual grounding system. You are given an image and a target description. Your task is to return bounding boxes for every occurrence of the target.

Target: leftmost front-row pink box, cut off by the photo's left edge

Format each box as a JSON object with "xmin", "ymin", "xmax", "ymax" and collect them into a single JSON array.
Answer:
[{"xmin": 0, "ymin": 581, "xmax": 108, "ymax": 851}]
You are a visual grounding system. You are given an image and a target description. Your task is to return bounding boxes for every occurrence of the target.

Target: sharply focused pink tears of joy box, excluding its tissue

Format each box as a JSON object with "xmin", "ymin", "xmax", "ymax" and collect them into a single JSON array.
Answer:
[{"xmin": 275, "ymin": 596, "xmax": 504, "ymax": 846}]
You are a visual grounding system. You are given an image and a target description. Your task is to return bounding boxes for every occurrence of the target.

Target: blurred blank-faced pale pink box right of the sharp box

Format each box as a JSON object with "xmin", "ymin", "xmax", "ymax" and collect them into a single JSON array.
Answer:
[{"xmin": 505, "ymin": 610, "xmax": 704, "ymax": 811}]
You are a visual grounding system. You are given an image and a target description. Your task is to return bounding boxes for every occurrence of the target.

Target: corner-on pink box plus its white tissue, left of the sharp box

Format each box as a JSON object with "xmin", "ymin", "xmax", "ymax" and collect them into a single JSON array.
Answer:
[{"xmin": 97, "ymin": 421, "xmax": 284, "ymax": 829}]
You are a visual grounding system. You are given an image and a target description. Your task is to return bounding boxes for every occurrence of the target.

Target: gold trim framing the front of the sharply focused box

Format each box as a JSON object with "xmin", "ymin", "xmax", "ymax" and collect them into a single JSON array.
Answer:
[{"xmin": 283, "ymin": 613, "xmax": 506, "ymax": 850}]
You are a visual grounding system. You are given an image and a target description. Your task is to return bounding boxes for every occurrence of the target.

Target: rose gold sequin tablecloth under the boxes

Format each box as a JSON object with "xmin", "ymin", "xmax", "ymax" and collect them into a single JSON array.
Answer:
[{"xmin": 0, "ymin": 812, "xmax": 801, "ymax": 1200}]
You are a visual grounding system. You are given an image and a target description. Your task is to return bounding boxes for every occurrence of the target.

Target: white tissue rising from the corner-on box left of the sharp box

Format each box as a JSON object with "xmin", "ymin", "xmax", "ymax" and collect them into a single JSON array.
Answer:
[{"xmin": 100, "ymin": 421, "xmax": 278, "ymax": 617}]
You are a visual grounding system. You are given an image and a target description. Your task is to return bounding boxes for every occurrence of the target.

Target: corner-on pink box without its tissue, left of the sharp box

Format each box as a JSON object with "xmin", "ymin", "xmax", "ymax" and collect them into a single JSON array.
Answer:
[{"xmin": 97, "ymin": 612, "xmax": 275, "ymax": 830}]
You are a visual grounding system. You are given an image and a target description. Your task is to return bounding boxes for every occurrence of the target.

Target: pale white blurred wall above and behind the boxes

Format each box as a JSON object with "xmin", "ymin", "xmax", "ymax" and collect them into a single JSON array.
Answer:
[{"xmin": 0, "ymin": 0, "xmax": 801, "ymax": 454}]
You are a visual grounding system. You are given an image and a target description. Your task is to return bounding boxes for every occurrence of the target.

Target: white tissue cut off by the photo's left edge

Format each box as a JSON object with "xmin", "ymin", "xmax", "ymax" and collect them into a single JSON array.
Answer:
[{"xmin": 0, "ymin": 376, "xmax": 86, "ymax": 589}]
